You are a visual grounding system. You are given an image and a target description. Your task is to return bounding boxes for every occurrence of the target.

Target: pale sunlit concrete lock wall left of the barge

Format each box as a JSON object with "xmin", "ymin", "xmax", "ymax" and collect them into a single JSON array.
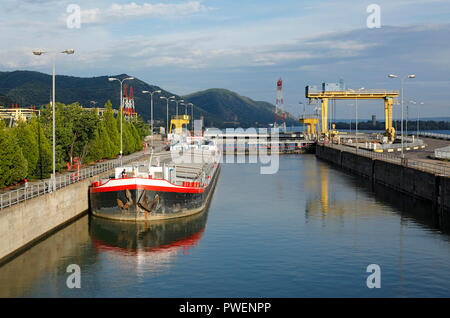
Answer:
[{"xmin": 0, "ymin": 170, "xmax": 112, "ymax": 262}]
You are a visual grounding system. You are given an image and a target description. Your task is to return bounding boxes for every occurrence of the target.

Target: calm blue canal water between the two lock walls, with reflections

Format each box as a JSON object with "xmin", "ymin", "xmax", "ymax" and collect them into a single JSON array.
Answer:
[{"xmin": 0, "ymin": 155, "xmax": 450, "ymax": 297}]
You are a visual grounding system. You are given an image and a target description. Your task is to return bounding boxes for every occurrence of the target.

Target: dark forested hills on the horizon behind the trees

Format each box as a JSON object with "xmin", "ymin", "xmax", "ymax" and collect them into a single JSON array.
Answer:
[{"xmin": 0, "ymin": 71, "xmax": 294, "ymax": 128}]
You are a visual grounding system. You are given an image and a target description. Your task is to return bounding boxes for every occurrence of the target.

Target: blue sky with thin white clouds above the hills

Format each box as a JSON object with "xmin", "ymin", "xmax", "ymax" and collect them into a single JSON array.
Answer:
[{"xmin": 0, "ymin": 0, "xmax": 450, "ymax": 119}]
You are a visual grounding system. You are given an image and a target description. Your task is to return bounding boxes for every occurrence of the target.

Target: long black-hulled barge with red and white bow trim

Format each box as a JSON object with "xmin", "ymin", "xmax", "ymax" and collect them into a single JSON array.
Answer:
[{"xmin": 89, "ymin": 138, "xmax": 220, "ymax": 221}]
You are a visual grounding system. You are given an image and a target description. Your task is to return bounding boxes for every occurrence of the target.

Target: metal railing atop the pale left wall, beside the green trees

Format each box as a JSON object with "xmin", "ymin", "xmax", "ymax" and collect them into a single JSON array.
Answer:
[{"xmin": 0, "ymin": 152, "xmax": 148, "ymax": 210}]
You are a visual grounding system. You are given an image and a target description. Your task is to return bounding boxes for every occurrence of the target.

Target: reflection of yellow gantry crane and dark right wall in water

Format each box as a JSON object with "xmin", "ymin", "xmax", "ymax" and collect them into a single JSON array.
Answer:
[{"xmin": 305, "ymin": 162, "xmax": 450, "ymax": 232}]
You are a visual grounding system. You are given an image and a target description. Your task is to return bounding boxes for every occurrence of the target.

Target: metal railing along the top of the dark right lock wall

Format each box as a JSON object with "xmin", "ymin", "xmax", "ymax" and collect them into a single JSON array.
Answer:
[{"xmin": 322, "ymin": 143, "xmax": 450, "ymax": 176}]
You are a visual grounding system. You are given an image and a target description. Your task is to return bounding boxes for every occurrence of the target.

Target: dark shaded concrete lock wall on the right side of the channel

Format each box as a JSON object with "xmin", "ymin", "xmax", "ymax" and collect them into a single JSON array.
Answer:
[{"xmin": 316, "ymin": 145, "xmax": 450, "ymax": 211}]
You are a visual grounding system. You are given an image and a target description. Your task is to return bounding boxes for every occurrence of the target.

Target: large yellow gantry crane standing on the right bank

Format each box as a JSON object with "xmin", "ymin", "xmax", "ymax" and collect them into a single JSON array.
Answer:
[{"xmin": 305, "ymin": 83, "xmax": 398, "ymax": 141}]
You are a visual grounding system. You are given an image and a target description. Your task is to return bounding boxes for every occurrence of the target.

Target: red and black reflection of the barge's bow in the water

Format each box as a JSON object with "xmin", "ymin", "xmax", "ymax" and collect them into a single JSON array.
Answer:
[{"xmin": 89, "ymin": 209, "xmax": 208, "ymax": 276}]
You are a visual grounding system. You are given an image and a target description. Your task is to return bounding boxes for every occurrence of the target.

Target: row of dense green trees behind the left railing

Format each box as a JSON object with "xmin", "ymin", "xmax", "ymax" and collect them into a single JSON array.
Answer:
[{"xmin": 0, "ymin": 101, "xmax": 149, "ymax": 187}]
